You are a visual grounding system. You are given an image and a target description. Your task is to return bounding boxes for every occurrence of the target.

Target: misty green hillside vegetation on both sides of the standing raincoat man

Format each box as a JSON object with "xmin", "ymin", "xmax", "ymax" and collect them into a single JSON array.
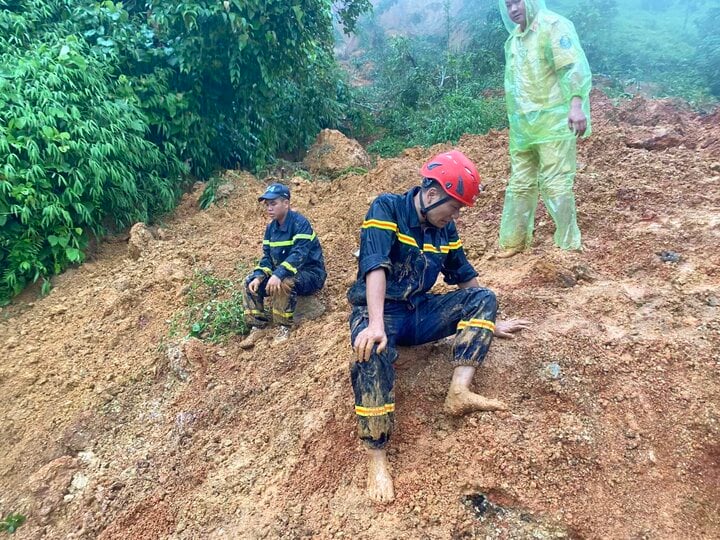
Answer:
[{"xmin": 346, "ymin": 0, "xmax": 720, "ymax": 156}]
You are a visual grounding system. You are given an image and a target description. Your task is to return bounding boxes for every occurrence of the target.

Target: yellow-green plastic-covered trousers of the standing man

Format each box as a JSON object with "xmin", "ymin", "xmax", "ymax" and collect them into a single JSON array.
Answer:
[{"xmin": 500, "ymin": 138, "xmax": 581, "ymax": 249}]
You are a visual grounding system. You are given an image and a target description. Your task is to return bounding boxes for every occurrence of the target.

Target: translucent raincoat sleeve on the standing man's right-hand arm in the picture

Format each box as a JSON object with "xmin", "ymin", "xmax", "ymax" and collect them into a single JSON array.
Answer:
[{"xmin": 550, "ymin": 19, "xmax": 592, "ymax": 102}]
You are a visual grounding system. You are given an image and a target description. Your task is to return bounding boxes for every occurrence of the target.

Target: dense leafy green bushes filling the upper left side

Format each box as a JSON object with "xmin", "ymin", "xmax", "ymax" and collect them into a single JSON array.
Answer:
[{"xmin": 0, "ymin": 0, "xmax": 369, "ymax": 302}]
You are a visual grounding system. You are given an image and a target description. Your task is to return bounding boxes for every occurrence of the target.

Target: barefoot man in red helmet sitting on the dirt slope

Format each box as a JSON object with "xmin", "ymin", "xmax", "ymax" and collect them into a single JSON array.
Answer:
[{"xmin": 348, "ymin": 150, "xmax": 528, "ymax": 502}]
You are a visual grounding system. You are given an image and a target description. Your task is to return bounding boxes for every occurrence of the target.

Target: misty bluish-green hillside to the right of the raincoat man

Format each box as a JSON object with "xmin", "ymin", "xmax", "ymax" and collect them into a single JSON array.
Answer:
[{"xmin": 563, "ymin": 0, "xmax": 720, "ymax": 105}]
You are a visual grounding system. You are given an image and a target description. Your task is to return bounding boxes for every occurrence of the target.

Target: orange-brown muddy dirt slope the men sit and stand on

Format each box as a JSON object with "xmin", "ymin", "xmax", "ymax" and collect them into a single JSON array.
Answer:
[{"xmin": 0, "ymin": 100, "xmax": 720, "ymax": 540}]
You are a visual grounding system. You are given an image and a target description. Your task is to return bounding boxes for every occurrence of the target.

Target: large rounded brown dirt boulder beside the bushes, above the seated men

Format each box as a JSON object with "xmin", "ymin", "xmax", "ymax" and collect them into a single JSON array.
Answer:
[{"xmin": 303, "ymin": 129, "xmax": 370, "ymax": 177}]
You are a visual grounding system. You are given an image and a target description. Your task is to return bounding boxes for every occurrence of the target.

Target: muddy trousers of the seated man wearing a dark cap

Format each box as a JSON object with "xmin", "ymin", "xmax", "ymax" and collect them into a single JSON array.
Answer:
[{"xmin": 243, "ymin": 270, "xmax": 325, "ymax": 328}]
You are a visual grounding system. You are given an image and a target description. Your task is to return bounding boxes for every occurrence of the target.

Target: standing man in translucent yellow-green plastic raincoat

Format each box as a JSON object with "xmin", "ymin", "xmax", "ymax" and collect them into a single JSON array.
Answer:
[{"xmin": 499, "ymin": 0, "xmax": 592, "ymax": 256}]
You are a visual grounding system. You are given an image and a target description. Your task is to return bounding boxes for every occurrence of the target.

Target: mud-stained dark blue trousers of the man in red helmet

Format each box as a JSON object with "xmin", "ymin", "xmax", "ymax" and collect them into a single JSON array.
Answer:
[{"xmin": 350, "ymin": 288, "xmax": 497, "ymax": 449}]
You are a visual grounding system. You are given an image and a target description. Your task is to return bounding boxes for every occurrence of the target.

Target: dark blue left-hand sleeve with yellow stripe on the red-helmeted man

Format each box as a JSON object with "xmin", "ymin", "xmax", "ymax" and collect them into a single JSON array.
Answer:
[{"xmin": 358, "ymin": 195, "xmax": 398, "ymax": 279}]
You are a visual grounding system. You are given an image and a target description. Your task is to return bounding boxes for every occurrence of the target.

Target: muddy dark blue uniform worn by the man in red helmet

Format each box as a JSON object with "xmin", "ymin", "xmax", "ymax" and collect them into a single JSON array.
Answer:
[{"xmin": 348, "ymin": 187, "xmax": 497, "ymax": 448}]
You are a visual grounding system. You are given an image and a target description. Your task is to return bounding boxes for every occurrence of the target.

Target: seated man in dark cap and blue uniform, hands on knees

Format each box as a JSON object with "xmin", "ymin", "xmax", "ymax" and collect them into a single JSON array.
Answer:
[{"xmin": 240, "ymin": 183, "xmax": 327, "ymax": 349}]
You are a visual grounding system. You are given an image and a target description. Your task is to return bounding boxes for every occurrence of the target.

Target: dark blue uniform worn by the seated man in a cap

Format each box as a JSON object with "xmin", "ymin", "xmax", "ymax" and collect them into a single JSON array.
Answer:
[{"xmin": 245, "ymin": 210, "xmax": 327, "ymax": 327}]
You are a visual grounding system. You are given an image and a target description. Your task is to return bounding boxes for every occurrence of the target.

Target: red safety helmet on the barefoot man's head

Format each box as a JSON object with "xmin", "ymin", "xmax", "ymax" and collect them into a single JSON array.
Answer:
[{"xmin": 420, "ymin": 150, "xmax": 480, "ymax": 206}]
